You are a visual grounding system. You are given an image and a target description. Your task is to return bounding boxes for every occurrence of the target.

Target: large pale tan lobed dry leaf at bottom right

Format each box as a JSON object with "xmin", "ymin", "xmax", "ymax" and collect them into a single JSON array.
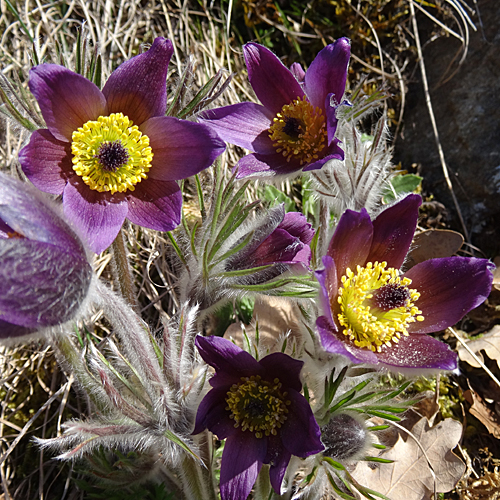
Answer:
[{"xmin": 353, "ymin": 418, "xmax": 465, "ymax": 500}]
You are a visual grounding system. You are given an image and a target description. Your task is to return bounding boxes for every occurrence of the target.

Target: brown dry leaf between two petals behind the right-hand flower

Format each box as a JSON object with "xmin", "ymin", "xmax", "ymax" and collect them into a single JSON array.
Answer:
[{"xmin": 406, "ymin": 229, "xmax": 464, "ymax": 267}]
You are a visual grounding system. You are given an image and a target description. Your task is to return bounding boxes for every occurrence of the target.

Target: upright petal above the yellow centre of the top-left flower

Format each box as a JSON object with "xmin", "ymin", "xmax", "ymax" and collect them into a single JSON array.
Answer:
[{"xmin": 102, "ymin": 37, "xmax": 174, "ymax": 125}]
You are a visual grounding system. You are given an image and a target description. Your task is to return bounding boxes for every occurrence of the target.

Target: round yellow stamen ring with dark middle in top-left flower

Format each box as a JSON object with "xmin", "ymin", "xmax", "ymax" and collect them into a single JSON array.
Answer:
[{"xmin": 71, "ymin": 113, "xmax": 153, "ymax": 194}]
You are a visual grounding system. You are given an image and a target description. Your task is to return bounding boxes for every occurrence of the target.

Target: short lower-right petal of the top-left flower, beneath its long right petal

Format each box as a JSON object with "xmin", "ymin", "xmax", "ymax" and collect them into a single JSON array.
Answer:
[{"xmin": 127, "ymin": 179, "xmax": 182, "ymax": 231}]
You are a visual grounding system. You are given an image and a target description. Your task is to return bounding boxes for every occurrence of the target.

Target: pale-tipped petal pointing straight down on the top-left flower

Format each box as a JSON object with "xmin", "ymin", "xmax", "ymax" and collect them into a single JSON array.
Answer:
[{"xmin": 63, "ymin": 176, "xmax": 128, "ymax": 253}]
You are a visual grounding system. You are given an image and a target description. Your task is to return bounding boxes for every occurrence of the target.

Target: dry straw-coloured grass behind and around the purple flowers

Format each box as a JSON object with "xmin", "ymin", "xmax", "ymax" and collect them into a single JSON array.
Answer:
[{"xmin": 0, "ymin": 0, "xmax": 492, "ymax": 500}]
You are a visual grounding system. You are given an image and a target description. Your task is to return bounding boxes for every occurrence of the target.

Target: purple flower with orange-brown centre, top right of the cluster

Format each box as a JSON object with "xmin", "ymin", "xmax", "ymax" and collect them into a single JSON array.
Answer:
[{"xmin": 200, "ymin": 38, "xmax": 350, "ymax": 178}]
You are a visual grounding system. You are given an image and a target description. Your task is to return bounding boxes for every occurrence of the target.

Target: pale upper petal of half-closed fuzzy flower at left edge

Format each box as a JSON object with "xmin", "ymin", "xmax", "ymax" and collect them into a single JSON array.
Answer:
[{"xmin": 0, "ymin": 174, "xmax": 85, "ymax": 259}]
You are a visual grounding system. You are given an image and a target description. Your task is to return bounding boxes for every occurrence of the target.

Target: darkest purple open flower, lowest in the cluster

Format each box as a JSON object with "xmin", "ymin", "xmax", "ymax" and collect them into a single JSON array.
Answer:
[{"xmin": 193, "ymin": 336, "xmax": 324, "ymax": 500}]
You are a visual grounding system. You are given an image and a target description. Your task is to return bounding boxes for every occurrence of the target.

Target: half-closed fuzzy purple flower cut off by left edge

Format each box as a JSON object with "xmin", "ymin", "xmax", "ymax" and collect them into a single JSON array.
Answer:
[{"xmin": 0, "ymin": 174, "xmax": 92, "ymax": 339}]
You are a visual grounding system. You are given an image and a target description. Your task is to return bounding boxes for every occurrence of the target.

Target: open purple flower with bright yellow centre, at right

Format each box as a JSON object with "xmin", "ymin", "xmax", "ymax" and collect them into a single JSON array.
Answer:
[{"xmin": 316, "ymin": 195, "xmax": 494, "ymax": 372}]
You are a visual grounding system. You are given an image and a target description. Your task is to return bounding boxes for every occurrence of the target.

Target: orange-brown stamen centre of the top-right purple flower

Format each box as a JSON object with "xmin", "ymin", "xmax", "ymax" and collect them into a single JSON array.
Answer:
[{"xmin": 269, "ymin": 97, "xmax": 327, "ymax": 165}]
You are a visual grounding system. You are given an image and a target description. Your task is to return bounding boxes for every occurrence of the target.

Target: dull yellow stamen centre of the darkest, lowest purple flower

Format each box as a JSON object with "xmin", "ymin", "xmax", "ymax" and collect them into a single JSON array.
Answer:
[{"xmin": 226, "ymin": 375, "xmax": 291, "ymax": 438}]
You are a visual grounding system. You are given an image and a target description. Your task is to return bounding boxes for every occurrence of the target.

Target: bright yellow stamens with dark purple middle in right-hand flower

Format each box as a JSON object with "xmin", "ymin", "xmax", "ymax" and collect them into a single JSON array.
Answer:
[{"xmin": 337, "ymin": 262, "xmax": 424, "ymax": 352}]
